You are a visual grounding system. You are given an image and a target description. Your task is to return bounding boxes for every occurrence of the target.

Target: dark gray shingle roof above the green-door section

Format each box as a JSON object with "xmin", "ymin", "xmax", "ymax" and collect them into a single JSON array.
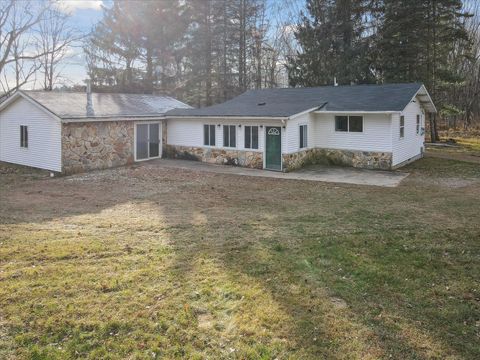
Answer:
[{"xmin": 167, "ymin": 83, "xmax": 433, "ymax": 117}]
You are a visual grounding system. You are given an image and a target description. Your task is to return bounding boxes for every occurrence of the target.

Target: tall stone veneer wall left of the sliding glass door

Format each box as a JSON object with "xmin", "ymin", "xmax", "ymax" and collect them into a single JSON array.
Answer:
[{"xmin": 62, "ymin": 121, "xmax": 134, "ymax": 174}]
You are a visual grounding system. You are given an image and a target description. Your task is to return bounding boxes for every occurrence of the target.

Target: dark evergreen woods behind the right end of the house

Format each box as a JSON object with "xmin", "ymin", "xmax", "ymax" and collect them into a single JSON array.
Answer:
[{"xmin": 288, "ymin": 0, "xmax": 480, "ymax": 139}]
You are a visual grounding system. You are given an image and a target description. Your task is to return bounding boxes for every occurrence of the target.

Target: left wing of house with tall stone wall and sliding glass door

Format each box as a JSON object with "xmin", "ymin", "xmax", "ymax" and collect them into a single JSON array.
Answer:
[{"xmin": 0, "ymin": 91, "xmax": 188, "ymax": 174}]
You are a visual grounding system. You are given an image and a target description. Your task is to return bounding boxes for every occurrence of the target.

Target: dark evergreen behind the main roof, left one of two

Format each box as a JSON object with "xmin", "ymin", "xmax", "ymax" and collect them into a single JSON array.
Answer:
[{"xmin": 288, "ymin": 0, "xmax": 374, "ymax": 86}]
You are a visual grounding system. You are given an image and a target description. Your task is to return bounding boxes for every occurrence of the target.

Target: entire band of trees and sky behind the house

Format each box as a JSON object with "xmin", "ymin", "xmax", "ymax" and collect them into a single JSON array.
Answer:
[{"xmin": 0, "ymin": 0, "xmax": 480, "ymax": 130}]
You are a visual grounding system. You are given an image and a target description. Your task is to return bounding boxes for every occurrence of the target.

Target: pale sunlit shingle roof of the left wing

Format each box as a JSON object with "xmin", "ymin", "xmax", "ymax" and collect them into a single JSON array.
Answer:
[{"xmin": 22, "ymin": 91, "xmax": 190, "ymax": 119}]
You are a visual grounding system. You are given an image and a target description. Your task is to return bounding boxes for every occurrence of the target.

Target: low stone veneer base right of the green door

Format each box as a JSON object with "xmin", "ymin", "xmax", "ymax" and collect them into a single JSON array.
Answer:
[{"xmin": 282, "ymin": 148, "xmax": 392, "ymax": 171}]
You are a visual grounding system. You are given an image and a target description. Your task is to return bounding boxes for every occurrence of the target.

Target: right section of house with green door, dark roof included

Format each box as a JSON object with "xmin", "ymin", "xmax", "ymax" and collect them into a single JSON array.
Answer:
[{"xmin": 166, "ymin": 84, "xmax": 436, "ymax": 171}]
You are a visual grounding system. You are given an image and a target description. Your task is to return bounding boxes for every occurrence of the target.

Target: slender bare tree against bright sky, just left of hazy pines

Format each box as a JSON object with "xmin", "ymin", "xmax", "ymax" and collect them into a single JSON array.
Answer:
[{"xmin": 36, "ymin": 8, "xmax": 81, "ymax": 91}]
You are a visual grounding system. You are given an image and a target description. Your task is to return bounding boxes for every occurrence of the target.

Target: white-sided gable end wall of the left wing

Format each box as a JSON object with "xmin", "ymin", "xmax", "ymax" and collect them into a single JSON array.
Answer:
[{"xmin": 0, "ymin": 98, "xmax": 62, "ymax": 172}]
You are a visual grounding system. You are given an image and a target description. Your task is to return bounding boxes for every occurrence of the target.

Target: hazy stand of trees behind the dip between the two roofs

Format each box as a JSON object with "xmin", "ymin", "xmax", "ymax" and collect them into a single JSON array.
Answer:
[{"xmin": 85, "ymin": 0, "xmax": 287, "ymax": 106}]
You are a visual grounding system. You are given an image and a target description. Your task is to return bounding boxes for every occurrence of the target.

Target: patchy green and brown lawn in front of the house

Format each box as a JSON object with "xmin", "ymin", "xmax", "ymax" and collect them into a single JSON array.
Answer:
[{"xmin": 0, "ymin": 158, "xmax": 480, "ymax": 359}]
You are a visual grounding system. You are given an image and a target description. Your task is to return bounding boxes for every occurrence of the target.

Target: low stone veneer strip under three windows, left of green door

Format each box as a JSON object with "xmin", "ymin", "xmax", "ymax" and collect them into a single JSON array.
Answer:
[{"xmin": 165, "ymin": 145, "xmax": 263, "ymax": 169}]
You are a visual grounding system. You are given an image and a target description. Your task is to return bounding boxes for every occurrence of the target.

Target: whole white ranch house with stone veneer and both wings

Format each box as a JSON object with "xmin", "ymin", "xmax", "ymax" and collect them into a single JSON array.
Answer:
[{"xmin": 0, "ymin": 83, "xmax": 436, "ymax": 173}]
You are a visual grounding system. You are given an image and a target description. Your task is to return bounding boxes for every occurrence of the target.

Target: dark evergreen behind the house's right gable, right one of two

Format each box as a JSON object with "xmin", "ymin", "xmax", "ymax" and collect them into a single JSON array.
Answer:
[{"xmin": 378, "ymin": 0, "xmax": 469, "ymax": 141}]
